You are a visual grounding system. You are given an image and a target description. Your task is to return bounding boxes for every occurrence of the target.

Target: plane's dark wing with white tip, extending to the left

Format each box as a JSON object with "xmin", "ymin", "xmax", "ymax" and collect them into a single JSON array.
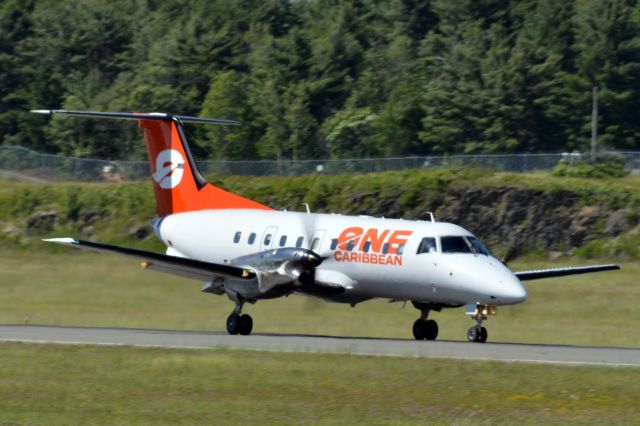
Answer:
[{"xmin": 43, "ymin": 238, "xmax": 256, "ymax": 281}]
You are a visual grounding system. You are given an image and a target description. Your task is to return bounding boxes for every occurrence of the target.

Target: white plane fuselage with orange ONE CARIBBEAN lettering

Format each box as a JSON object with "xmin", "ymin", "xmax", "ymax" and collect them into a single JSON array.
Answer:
[{"xmin": 156, "ymin": 209, "xmax": 527, "ymax": 306}]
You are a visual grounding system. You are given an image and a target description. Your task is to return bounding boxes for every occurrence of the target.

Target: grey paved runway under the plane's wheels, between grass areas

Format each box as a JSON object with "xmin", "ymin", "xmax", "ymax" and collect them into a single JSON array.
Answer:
[{"xmin": 0, "ymin": 325, "xmax": 640, "ymax": 366}]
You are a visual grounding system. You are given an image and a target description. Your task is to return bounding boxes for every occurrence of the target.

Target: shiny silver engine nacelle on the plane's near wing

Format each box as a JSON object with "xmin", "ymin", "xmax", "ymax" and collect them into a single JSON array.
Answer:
[{"xmin": 229, "ymin": 247, "xmax": 322, "ymax": 293}]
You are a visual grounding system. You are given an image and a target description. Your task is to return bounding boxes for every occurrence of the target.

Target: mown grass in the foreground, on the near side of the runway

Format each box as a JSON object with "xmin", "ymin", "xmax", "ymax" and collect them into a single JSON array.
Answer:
[{"xmin": 0, "ymin": 343, "xmax": 640, "ymax": 425}]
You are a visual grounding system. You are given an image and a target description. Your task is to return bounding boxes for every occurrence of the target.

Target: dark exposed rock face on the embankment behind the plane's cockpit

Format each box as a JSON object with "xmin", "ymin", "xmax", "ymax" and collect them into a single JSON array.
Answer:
[{"xmin": 424, "ymin": 186, "xmax": 638, "ymax": 253}]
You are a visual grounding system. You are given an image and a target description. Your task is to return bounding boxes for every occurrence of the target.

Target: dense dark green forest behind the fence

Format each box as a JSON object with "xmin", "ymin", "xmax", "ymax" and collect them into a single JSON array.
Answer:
[{"xmin": 0, "ymin": 0, "xmax": 640, "ymax": 159}]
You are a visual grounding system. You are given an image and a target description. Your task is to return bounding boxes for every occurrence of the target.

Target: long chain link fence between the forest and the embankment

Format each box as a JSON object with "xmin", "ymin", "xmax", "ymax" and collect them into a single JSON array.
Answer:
[{"xmin": 0, "ymin": 145, "xmax": 640, "ymax": 182}]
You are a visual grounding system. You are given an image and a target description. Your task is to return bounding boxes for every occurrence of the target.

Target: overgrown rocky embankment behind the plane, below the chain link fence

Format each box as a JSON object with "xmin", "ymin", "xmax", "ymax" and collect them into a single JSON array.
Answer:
[{"xmin": 5, "ymin": 181, "xmax": 640, "ymax": 258}]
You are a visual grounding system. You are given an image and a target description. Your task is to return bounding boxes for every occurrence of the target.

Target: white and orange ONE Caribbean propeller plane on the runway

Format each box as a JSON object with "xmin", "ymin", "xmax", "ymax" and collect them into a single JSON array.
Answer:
[{"xmin": 33, "ymin": 110, "xmax": 619, "ymax": 342}]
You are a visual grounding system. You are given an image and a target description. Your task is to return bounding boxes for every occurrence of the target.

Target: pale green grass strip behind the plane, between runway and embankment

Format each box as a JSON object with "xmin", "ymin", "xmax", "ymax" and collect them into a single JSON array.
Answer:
[{"xmin": 0, "ymin": 249, "xmax": 640, "ymax": 347}]
